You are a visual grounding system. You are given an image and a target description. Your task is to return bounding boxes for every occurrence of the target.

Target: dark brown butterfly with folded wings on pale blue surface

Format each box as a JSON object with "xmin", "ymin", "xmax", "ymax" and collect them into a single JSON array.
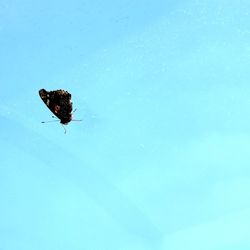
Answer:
[{"xmin": 39, "ymin": 89, "xmax": 81, "ymax": 133}]
